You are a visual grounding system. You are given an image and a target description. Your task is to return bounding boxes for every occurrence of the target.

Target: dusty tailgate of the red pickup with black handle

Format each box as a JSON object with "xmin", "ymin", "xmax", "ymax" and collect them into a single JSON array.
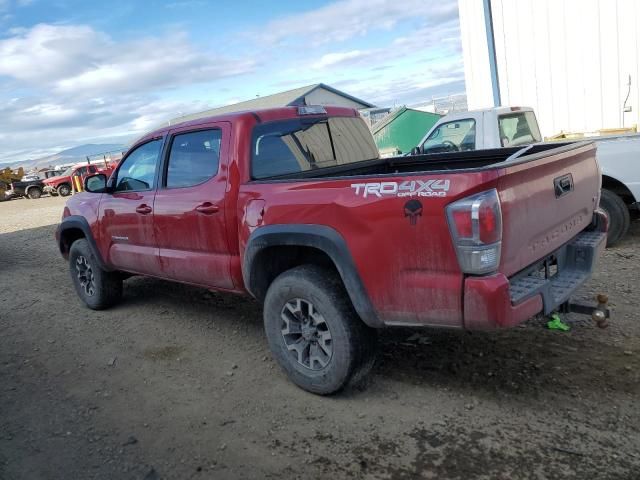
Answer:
[{"xmin": 498, "ymin": 142, "xmax": 600, "ymax": 276}]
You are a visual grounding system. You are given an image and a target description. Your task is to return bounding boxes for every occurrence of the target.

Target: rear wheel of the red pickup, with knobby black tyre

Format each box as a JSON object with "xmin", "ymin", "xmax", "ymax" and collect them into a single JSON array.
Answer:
[{"xmin": 264, "ymin": 265, "xmax": 377, "ymax": 395}]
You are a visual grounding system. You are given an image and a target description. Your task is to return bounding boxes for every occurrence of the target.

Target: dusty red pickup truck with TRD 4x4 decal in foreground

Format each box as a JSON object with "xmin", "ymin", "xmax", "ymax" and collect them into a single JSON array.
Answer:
[{"xmin": 56, "ymin": 106, "xmax": 607, "ymax": 394}]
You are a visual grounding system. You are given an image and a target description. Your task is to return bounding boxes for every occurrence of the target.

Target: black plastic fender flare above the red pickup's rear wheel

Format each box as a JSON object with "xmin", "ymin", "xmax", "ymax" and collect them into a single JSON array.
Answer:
[{"xmin": 242, "ymin": 224, "xmax": 384, "ymax": 328}]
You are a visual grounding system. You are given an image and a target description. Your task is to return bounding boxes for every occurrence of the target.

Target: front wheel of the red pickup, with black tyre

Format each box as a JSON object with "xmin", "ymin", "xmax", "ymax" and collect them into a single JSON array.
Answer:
[{"xmin": 69, "ymin": 238, "xmax": 122, "ymax": 310}]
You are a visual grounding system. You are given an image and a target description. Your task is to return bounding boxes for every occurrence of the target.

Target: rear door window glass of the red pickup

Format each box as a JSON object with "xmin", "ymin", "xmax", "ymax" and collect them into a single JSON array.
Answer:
[{"xmin": 166, "ymin": 129, "xmax": 222, "ymax": 188}]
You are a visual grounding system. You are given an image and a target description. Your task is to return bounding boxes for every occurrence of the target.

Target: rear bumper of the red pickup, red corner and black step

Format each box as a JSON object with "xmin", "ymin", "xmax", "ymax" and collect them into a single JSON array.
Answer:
[{"xmin": 464, "ymin": 212, "xmax": 607, "ymax": 329}]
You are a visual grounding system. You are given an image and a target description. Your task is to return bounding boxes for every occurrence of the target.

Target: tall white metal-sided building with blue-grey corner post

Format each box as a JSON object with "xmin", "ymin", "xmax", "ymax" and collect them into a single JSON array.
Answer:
[{"xmin": 458, "ymin": 0, "xmax": 640, "ymax": 136}]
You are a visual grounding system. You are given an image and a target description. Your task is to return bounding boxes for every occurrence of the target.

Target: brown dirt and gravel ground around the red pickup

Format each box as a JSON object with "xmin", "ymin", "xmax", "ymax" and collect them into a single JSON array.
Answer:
[{"xmin": 0, "ymin": 198, "xmax": 640, "ymax": 480}]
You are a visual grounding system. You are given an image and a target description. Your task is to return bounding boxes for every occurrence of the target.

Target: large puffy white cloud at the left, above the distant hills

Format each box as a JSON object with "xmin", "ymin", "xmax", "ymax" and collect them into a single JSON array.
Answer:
[{"xmin": 0, "ymin": 24, "xmax": 255, "ymax": 95}]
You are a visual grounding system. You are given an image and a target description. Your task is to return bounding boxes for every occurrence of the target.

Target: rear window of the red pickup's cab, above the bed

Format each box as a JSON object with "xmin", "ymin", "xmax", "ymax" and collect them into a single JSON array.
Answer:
[{"xmin": 251, "ymin": 117, "xmax": 378, "ymax": 179}]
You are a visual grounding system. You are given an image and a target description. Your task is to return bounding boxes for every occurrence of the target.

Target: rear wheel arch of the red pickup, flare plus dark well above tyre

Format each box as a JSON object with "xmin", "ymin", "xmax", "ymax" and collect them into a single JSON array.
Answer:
[{"xmin": 242, "ymin": 224, "xmax": 383, "ymax": 328}]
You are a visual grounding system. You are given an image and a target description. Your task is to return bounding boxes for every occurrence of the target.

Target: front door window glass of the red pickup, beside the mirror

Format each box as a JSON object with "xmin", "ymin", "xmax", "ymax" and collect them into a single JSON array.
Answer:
[{"xmin": 116, "ymin": 139, "xmax": 162, "ymax": 192}]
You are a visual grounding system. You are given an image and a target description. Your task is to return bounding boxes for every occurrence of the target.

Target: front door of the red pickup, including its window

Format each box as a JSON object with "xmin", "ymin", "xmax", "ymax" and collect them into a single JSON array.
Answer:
[{"xmin": 100, "ymin": 138, "xmax": 162, "ymax": 275}]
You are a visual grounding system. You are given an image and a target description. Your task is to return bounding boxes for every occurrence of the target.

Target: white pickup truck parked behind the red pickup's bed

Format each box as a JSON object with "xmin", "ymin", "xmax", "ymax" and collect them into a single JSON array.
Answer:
[{"xmin": 412, "ymin": 107, "xmax": 640, "ymax": 246}]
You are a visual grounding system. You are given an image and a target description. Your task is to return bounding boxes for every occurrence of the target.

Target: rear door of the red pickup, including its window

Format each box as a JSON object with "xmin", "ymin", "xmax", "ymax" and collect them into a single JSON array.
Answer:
[{"xmin": 154, "ymin": 122, "xmax": 233, "ymax": 289}]
